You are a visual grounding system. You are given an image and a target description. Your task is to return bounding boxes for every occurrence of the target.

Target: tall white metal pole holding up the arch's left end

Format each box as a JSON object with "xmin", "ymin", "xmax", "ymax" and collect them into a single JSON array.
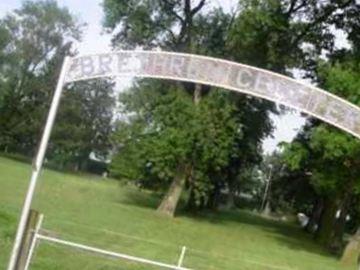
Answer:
[{"xmin": 7, "ymin": 57, "xmax": 70, "ymax": 270}]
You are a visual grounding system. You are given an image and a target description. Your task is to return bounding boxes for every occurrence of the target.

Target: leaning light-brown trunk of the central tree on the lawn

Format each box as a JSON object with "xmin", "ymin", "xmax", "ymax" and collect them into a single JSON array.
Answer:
[{"xmin": 157, "ymin": 165, "xmax": 189, "ymax": 217}]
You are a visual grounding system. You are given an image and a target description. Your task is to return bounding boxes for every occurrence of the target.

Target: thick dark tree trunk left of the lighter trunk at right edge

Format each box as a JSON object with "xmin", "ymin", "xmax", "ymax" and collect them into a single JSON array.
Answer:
[{"xmin": 315, "ymin": 198, "xmax": 339, "ymax": 247}]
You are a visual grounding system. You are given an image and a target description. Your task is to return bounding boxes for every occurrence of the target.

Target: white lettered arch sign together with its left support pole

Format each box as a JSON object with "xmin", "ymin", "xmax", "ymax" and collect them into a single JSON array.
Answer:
[{"xmin": 8, "ymin": 51, "xmax": 360, "ymax": 270}]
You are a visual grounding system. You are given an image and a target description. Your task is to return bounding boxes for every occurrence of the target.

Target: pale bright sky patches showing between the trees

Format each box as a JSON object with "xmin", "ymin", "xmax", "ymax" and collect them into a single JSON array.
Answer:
[{"xmin": 0, "ymin": 0, "xmax": 305, "ymax": 153}]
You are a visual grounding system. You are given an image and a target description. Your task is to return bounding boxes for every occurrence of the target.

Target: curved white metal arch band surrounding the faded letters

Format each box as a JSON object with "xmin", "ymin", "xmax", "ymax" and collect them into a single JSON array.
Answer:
[{"xmin": 66, "ymin": 51, "xmax": 360, "ymax": 139}]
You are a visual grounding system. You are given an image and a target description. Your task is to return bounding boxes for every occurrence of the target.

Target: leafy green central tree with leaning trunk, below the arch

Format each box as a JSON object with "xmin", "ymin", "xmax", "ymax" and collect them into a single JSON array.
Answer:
[{"xmin": 113, "ymin": 82, "xmax": 241, "ymax": 213}]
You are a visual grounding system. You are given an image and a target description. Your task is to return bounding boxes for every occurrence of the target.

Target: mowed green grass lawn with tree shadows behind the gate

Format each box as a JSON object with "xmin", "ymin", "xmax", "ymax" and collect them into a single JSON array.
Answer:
[{"xmin": 0, "ymin": 157, "xmax": 355, "ymax": 270}]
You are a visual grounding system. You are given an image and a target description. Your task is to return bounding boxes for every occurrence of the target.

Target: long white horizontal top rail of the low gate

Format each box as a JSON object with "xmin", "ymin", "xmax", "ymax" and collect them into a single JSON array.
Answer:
[{"xmin": 38, "ymin": 234, "xmax": 190, "ymax": 270}]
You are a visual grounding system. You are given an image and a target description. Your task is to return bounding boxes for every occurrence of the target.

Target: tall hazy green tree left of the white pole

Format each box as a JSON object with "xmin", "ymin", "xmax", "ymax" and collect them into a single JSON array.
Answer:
[{"xmin": 0, "ymin": 1, "xmax": 80, "ymax": 155}]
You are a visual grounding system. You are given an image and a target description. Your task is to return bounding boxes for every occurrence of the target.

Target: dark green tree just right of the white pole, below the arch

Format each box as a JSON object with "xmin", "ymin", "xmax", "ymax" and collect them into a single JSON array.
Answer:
[{"xmin": 49, "ymin": 80, "xmax": 115, "ymax": 170}]
